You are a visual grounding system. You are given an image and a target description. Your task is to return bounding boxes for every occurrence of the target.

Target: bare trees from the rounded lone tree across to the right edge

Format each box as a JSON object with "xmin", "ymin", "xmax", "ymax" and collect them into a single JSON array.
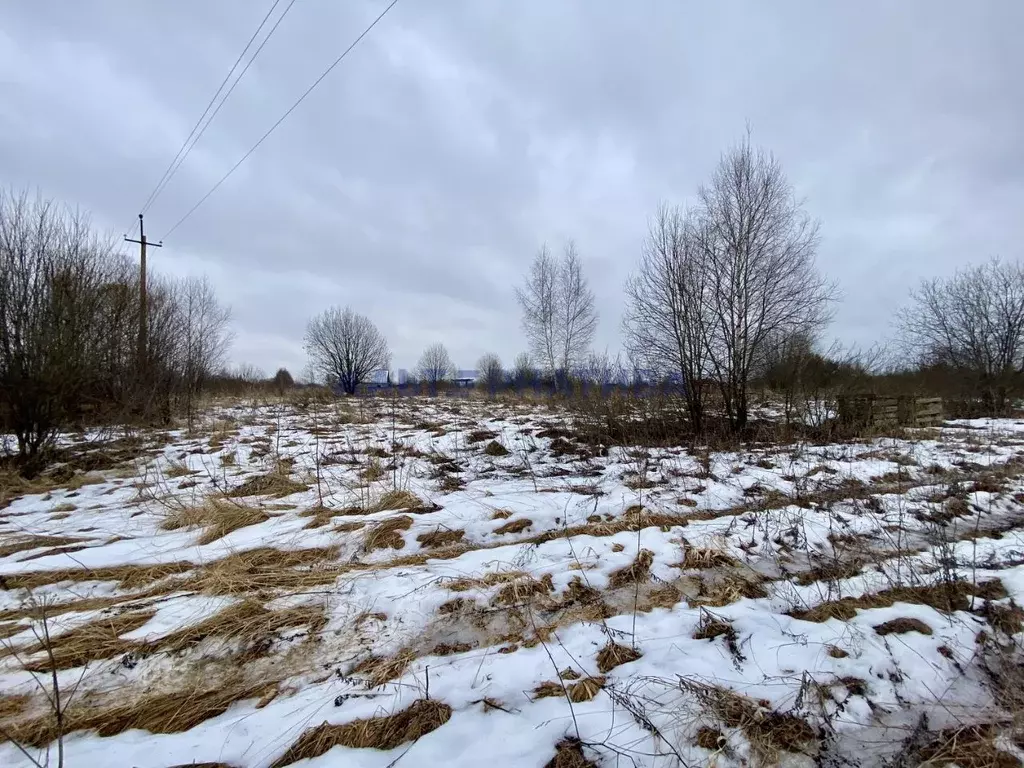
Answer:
[{"xmin": 306, "ymin": 134, "xmax": 1024, "ymax": 433}]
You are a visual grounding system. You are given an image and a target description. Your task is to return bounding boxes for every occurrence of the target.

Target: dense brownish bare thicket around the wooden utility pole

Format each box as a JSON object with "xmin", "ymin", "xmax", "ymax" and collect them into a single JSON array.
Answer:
[{"xmin": 0, "ymin": 190, "xmax": 231, "ymax": 464}]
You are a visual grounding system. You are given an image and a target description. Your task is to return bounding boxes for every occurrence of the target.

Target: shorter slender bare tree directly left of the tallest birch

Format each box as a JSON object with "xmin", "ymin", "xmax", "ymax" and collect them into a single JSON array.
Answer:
[{"xmin": 623, "ymin": 204, "xmax": 712, "ymax": 433}]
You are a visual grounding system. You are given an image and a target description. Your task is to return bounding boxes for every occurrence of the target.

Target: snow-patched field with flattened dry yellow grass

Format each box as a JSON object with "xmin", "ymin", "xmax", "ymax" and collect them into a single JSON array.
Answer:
[{"xmin": 0, "ymin": 398, "xmax": 1024, "ymax": 768}]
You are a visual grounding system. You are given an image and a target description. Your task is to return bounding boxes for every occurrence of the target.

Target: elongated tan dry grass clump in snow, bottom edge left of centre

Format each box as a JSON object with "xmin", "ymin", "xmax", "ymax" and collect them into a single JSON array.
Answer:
[{"xmin": 270, "ymin": 698, "xmax": 452, "ymax": 768}]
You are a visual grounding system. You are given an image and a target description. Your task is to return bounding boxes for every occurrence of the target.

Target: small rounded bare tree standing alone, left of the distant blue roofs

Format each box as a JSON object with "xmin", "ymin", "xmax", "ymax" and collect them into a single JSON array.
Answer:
[{"xmin": 305, "ymin": 307, "xmax": 391, "ymax": 394}]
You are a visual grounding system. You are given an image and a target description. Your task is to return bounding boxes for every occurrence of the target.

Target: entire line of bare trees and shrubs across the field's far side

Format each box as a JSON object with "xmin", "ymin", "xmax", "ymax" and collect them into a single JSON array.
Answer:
[{"xmin": 0, "ymin": 135, "xmax": 1024, "ymax": 461}]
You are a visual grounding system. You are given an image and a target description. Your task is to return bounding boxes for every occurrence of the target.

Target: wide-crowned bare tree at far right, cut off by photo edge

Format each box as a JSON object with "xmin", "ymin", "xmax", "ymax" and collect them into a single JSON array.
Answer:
[{"xmin": 899, "ymin": 259, "xmax": 1024, "ymax": 412}]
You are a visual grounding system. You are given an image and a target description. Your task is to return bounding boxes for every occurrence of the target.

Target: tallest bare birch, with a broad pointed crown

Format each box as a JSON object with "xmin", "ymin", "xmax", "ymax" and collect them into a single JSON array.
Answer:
[{"xmin": 694, "ymin": 135, "xmax": 836, "ymax": 430}]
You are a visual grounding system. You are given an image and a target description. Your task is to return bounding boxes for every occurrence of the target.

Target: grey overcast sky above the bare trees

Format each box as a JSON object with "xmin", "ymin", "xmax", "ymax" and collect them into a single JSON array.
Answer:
[{"xmin": 0, "ymin": 0, "xmax": 1024, "ymax": 373}]
